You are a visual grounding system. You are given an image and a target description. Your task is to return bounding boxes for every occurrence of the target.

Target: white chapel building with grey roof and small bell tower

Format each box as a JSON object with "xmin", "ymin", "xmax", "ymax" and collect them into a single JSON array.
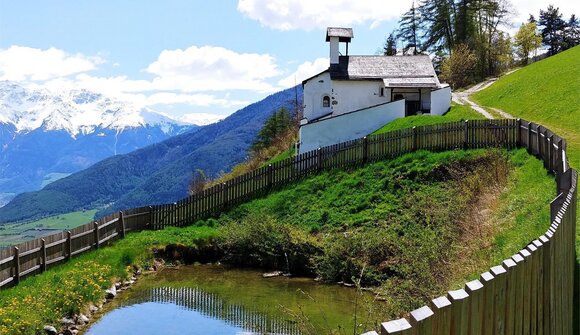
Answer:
[{"xmin": 299, "ymin": 28, "xmax": 451, "ymax": 153}]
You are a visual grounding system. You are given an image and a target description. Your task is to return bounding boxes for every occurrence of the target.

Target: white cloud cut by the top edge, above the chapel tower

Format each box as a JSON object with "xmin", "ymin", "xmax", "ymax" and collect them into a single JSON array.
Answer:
[{"xmin": 233, "ymin": 0, "xmax": 411, "ymax": 30}]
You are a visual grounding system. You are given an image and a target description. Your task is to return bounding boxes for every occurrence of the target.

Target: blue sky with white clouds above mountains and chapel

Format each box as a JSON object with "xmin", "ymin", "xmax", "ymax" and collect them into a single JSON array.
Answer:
[{"xmin": 0, "ymin": 0, "xmax": 580, "ymax": 124}]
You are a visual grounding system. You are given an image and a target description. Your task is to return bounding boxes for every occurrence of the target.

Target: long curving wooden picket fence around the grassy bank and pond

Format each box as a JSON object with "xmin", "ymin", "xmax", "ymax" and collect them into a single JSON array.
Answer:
[{"xmin": 0, "ymin": 119, "xmax": 577, "ymax": 334}]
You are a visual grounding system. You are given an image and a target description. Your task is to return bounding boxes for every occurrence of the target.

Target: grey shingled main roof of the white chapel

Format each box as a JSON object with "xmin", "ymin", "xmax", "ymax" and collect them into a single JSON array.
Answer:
[{"xmin": 329, "ymin": 55, "xmax": 439, "ymax": 87}]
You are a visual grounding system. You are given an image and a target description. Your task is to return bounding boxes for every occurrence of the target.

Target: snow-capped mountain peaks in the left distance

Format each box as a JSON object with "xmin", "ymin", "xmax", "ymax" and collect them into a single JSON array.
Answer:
[{"xmin": 0, "ymin": 81, "xmax": 191, "ymax": 137}]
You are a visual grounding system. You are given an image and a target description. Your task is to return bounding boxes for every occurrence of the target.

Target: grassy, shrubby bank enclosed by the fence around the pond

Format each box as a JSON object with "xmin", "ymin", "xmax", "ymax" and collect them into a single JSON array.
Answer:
[{"xmin": 0, "ymin": 149, "xmax": 554, "ymax": 334}]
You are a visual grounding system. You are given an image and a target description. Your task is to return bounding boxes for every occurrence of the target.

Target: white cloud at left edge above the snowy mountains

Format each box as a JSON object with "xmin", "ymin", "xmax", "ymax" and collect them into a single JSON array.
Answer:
[{"xmin": 0, "ymin": 45, "xmax": 104, "ymax": 81}]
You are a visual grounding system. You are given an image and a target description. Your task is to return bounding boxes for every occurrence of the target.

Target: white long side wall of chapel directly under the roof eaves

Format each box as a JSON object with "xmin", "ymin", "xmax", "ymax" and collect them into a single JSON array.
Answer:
[{"xmin": 332, "ymin": 80, "xmax": 391, "ymax": 115}]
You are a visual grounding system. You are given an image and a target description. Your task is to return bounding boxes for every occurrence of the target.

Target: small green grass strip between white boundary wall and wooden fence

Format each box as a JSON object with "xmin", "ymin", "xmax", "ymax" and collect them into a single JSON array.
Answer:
[{"xmin": 373, "ymin": 103, "xmax": 484, "ymax": 134}]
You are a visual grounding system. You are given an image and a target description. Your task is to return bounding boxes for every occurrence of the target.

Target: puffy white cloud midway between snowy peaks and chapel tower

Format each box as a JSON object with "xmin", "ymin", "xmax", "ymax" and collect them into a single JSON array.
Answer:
[{"xmin": 147, "ymin": 46, "xmax": 280, "ymax": 92}]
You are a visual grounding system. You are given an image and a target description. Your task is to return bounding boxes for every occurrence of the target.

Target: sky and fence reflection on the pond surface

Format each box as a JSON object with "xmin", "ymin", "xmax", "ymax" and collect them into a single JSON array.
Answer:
[{"xmin": 87, "ymin": 287, "xmax": 301, "ymax": 335}]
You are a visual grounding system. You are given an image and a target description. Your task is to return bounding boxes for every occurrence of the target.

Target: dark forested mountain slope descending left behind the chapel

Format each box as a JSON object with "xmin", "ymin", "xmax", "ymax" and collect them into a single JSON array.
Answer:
[{"xmin": 0, "ymin": 86, "xmax": 302, "ymax": 223}]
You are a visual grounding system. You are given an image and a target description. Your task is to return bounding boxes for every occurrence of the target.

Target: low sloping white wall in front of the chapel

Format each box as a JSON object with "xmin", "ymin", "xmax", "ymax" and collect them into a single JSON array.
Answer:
[{"xmin": 299, "ymin": 100, "xmax": 405, "ymax": 153}]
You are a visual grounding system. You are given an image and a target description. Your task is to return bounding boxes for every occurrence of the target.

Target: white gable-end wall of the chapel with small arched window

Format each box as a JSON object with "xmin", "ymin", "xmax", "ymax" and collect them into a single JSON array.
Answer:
[{"xmin": 304, "ymin": 72, "xmax": 332, "ymax": 120}]
